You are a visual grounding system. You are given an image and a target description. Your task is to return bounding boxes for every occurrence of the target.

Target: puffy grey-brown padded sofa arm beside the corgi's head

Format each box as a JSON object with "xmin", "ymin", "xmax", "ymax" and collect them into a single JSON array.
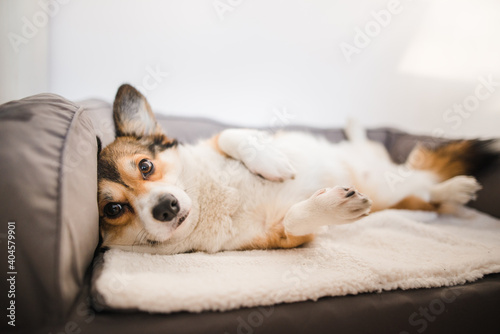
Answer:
[{"xmin": 0, "ymin": 94, "xmax": 98, "ymax": 329}]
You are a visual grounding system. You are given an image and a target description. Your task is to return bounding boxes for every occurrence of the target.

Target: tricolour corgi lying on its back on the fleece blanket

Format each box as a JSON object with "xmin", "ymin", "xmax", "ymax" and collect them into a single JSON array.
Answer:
[{"xmin": 98, "ymin": 84, "xmax": 500, "ymax": 254}]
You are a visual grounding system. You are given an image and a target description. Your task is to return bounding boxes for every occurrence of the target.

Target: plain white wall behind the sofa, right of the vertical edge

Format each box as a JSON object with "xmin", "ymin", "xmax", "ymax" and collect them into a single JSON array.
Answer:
[{"xmin": 0, "ymin": 0, "xmax": 500, "ymax": 137}]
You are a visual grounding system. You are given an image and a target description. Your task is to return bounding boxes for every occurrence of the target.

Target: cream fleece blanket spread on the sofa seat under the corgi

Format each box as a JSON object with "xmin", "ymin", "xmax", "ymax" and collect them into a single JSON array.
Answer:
[{"xmin": 94, "ymin": 209, "xmax": 500, "ymax": 312}]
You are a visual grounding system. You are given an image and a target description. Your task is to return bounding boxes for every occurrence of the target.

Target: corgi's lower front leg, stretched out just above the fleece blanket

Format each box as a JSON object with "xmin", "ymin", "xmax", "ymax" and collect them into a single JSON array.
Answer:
[{"xmin": 283, "ymin": 187, "xmax": 372, "ymax": 236}]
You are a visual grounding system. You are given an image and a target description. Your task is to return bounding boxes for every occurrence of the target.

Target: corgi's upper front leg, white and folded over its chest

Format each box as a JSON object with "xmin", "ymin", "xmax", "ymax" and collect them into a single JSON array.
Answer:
[{"xmin": 215, "ymin": 129, "xmax": 295, "ymax": 181}]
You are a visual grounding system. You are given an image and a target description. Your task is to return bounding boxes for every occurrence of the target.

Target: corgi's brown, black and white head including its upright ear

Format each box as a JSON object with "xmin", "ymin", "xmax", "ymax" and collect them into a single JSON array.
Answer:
[{"xmin": 98, "ymin": 85, "xmax": 193, "ymax": 247}]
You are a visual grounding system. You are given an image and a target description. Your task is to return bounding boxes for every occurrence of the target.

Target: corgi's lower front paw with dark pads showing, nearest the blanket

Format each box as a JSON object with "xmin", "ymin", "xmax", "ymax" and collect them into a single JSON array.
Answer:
[{"xmin": 310, "ymin": 186, "xmax": 372, "ymax": 223}]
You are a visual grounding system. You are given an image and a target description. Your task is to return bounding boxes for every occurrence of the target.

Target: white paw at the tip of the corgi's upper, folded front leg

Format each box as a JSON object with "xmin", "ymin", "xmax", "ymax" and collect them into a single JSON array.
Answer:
[{"xmin": 243, "ymin": 145, "xmax": 295, "ymax": 182}]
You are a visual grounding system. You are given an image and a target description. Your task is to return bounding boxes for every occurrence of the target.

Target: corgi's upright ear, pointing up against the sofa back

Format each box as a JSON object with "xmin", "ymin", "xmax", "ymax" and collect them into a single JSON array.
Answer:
[{"xmin": 113, "ymin": 84, "xmax": 163, "ymax": 138}]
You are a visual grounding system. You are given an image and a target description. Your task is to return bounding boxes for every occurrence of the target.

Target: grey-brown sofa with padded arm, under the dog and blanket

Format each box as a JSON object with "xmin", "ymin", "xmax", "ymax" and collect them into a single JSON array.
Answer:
[{"xmin": 0, "ymin": 94, "xmax": 500, "ymax": 333}]
